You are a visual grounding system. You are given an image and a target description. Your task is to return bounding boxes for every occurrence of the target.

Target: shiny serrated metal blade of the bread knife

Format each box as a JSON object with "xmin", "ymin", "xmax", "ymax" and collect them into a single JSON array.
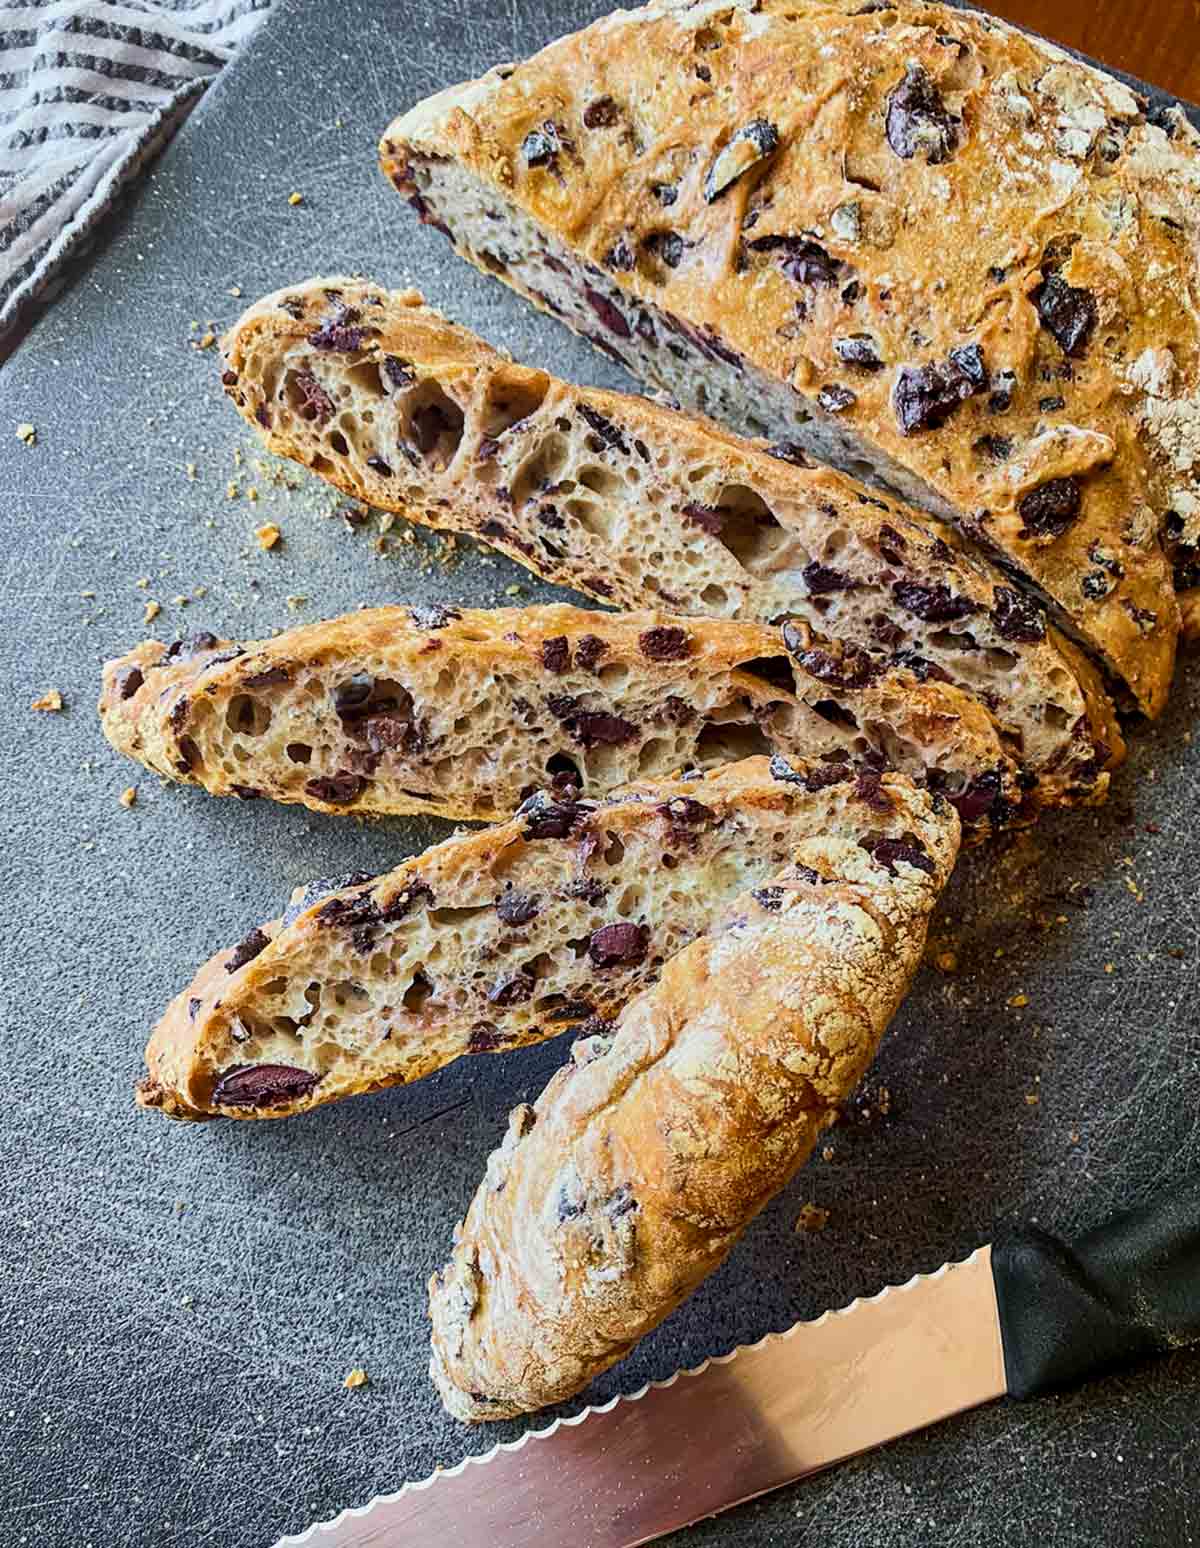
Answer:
[{"xmin": 277, "ymin": 1248, "xmax": 1005, "ymax": 1548}]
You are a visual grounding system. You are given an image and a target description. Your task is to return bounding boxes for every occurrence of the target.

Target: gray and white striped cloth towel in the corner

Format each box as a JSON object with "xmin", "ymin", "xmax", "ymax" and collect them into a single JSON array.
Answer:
[{"xmin": 0, "ymin": 0, "xmax": 271, "ymax": 358}]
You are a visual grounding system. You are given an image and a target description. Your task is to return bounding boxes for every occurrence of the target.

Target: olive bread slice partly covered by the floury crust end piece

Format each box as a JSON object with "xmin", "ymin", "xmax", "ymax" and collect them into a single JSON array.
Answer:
[{"xmin": 138, "ymin": 759, "xmax": 957, "ymax": 1118}]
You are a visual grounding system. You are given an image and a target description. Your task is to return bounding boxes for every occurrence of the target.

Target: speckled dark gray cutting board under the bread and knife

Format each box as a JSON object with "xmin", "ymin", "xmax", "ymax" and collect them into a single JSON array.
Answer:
[{"xmin": 0, "ymin": 0, "xmax": 1200, "ymax": 1548}]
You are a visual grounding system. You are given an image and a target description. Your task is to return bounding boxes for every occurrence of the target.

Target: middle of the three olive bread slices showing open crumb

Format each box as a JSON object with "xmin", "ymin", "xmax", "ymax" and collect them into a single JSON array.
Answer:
[{"xmin": 101, "ymin": 605, "xmax": 1034, "ymax": 833}]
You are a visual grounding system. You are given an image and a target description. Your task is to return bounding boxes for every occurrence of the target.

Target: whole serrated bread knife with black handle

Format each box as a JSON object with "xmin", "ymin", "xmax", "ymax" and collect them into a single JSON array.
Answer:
[{"xmin": 277, "ymin": 1175, "xmax": 1200, "ymax": 1548}]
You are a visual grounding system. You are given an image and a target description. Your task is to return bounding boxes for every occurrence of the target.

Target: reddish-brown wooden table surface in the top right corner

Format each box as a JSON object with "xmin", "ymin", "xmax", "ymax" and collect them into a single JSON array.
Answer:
[{"xmin": 983, "ymin": 0, "xmax": 1200, "ymax": 102}]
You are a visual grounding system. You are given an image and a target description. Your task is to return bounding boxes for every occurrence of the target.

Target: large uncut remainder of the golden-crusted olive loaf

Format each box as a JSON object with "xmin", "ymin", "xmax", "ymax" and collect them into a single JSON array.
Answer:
[{"xmin": 381, "ymin": 0, "xmax": 1200, "ymax": 714}]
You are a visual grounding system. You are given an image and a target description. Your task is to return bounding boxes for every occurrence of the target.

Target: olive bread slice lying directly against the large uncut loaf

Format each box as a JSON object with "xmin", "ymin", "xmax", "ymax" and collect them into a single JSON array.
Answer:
[{"xmin": 225, "ymin": 279, "xmax": 1124, "ymax": 803}]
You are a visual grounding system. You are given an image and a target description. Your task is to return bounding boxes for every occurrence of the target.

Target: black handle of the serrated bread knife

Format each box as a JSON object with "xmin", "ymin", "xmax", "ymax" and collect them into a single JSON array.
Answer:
[{"xmin": 991, "ymin": 1175, "xmax": 1200, "ymax": 1398}]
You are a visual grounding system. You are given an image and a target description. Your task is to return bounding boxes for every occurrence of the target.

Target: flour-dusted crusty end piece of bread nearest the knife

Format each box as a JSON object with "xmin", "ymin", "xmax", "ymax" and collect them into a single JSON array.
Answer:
[{"xmin": 430, "ymin": 761, "xmax": 958, "ymax": 1421}]
